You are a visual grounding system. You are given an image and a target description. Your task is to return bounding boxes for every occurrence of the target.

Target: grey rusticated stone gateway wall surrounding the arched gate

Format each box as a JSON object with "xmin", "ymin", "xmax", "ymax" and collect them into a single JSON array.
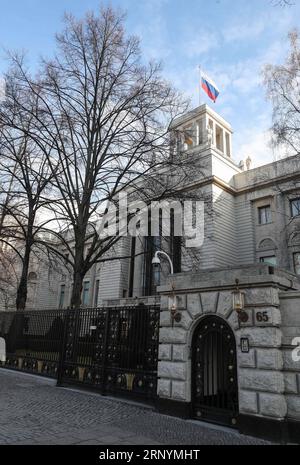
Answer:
[{"xmin": 158, "ymin": 265, "xmax": 300, "ymax": 440}]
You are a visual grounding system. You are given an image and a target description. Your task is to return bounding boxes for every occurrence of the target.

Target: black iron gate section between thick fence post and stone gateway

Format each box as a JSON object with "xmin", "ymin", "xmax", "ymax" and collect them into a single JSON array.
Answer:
[{"xmin": 58, "ymin": 305, "xmax": 159, "ymax": 400}]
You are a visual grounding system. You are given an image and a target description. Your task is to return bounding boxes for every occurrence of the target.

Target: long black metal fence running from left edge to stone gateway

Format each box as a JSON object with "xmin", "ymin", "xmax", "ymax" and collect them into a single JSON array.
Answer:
[{"xmin": 0, "ymin": 305, "xmax": 159, "ymax": 400}]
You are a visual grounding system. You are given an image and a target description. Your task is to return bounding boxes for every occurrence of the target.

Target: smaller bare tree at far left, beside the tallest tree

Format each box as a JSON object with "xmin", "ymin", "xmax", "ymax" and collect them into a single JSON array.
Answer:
[{"xmin": 0, "ymin": 93, "xmax": 52, "ymax": 310}]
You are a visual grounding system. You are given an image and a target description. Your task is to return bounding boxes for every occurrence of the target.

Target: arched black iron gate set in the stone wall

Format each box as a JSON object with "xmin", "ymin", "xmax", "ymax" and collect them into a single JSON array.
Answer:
[{"xmin": 192, "ymin": 316, "xmax": 238, "ymax": 426}]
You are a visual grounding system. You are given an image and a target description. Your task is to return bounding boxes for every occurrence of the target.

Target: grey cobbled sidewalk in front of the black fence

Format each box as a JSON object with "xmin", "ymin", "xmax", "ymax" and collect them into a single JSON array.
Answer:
[{"xmin": 0, "ymin": 369, "xmax": 267, "ymax": 445}]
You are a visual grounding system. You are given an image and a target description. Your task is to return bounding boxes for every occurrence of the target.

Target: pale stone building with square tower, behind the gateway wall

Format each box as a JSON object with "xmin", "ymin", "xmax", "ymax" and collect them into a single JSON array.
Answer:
[{"xmin": 11, "ymin": 105, "xmax": 300, "ymax": 308}]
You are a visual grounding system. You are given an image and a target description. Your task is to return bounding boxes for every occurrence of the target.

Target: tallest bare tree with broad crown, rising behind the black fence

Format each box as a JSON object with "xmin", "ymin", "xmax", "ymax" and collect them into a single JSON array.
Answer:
[{"xmin": 1, "ymin": 8, "xmax": 202, "ymax": 307}]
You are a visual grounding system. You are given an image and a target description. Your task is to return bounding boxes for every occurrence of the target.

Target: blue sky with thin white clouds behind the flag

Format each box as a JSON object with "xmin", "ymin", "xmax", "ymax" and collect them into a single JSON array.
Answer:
[{"xmin": 0, "ymin": 0, "xmax": 300, "ymax": 165}]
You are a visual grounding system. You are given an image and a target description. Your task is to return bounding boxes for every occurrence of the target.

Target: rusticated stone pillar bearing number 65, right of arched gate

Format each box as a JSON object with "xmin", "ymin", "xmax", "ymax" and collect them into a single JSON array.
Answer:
[{"xmin": 237, "ymin": 287, "xmax": 287, "ymax": 440}]
